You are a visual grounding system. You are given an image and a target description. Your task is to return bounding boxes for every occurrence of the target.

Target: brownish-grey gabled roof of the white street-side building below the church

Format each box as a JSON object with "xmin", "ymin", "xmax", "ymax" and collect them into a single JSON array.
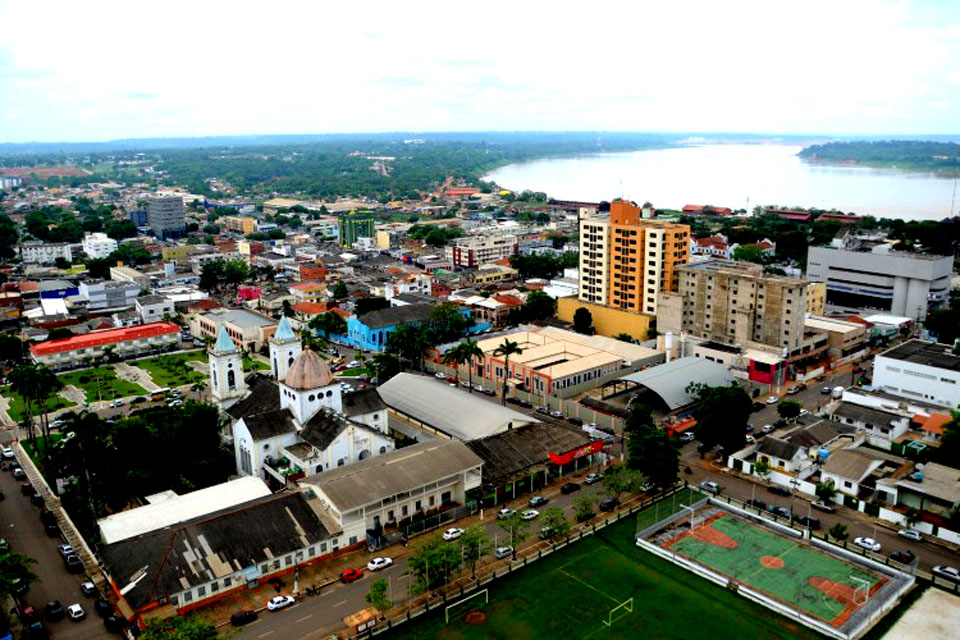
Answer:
[{"xmin": 300, "ymin": 440, "xmax": 483, "ymax": 514}]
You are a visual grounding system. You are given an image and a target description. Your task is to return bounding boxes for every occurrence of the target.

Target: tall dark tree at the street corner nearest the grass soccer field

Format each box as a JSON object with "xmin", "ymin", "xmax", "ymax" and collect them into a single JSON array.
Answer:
[{"xmin": 624, "ymin": 405, "xmax": 680, "ymax": 491}]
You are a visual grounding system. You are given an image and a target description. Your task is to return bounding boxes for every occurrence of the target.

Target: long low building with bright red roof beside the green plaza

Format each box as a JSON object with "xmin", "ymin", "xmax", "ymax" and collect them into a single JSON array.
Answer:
[{"xmin": 30, "ymin": 322, "xmax": 180, "ymax": 369}]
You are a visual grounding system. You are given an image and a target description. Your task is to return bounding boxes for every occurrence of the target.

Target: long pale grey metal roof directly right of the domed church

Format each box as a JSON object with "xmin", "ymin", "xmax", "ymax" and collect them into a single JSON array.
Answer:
[{"xmin": 378, "ymin": 373, "xmax": 539, "ymax": 442}]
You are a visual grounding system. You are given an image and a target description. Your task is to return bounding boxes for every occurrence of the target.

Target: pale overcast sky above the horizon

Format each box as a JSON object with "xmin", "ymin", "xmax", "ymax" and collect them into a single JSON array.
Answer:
[{"xmin": 0, "ymin": 0, "xmax": 960, "ymax": 142}]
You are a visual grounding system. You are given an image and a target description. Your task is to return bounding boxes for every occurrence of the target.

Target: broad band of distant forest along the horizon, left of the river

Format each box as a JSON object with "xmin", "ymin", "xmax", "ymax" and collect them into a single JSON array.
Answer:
[{"xmin": 0, "ymin": 132, "xmax": 681, "ymax": 202}]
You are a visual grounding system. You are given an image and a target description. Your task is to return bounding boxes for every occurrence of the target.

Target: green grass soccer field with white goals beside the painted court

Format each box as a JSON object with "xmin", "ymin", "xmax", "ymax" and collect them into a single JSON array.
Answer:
[{"xmin": 382, "ymin": 488, "xmax": 820, "ymax": 640}]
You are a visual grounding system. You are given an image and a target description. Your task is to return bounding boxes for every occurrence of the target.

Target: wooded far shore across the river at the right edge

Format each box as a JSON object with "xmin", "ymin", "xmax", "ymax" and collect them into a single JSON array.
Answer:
[{"xmin": 800, "ymin": 140, "xmax": 960, "ymax": 173}]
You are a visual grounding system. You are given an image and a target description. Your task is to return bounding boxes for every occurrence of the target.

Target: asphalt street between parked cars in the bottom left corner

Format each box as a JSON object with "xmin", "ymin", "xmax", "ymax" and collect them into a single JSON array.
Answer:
[{"xmin": 0, "ymin": 456, "xmax": 116, "ymax": 640}]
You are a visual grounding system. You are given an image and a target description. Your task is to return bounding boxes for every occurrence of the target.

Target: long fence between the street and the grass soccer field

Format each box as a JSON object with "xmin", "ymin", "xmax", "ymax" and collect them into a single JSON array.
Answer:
[{"xmin": 348, "ymin": 482, "xmax": 687, "ymax": 638}]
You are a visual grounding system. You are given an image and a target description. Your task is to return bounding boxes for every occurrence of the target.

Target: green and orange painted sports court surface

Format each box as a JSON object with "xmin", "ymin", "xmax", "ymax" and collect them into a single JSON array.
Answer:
[{"xmin": 662, "ymin": 512, "xmax": 886, "ymax": 627}]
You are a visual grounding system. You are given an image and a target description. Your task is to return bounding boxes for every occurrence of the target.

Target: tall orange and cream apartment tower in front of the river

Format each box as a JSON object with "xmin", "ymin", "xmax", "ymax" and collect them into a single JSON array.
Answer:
[{"xmin": 578, "ymin": 200, "xmax": 690, "ymax": 314}]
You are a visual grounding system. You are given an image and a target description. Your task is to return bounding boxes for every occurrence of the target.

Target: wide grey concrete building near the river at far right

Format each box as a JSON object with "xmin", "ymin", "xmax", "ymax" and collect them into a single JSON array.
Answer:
[{"xmin": 807, "ymin": 239, "xmax": 953, "ymax": 320}]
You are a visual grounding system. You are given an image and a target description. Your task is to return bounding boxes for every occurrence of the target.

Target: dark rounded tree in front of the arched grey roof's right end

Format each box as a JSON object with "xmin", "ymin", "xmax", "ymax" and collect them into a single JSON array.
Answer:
[{"xmin": 687, "ymin": 383, "xmax": 753, "ymax": 453}]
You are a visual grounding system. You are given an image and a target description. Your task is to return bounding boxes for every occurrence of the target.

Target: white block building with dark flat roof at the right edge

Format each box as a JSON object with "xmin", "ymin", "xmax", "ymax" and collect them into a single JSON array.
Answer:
[{"xmin": 873, "ymin": 340, "xmax": 960, "ymax": 409}]
